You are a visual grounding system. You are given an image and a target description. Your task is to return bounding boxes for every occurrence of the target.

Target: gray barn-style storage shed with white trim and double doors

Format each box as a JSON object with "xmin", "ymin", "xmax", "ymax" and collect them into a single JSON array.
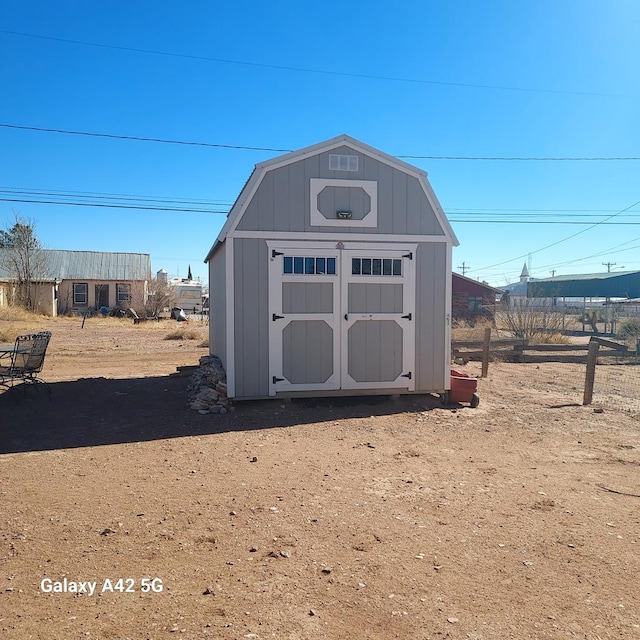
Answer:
[{"xmin": 205, "ymin": 135, "xmax": 458, "ymax": 399}]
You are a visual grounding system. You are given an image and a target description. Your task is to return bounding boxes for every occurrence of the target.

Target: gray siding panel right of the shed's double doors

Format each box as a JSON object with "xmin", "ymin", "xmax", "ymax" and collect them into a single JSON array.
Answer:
[{"xmin": 416, "ymin": 242, "xmax": 450, "ymax": 390}]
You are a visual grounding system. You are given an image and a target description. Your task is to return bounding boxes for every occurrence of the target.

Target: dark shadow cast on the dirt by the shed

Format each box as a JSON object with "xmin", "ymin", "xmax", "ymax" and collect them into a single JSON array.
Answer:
[{"xmin": 0, "ymin": 376, "xmax": 448, "ymax": 454}]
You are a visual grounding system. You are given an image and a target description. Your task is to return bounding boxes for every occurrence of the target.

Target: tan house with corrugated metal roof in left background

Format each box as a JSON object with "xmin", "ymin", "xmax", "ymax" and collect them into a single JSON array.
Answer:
[{"xmin": 0, "ymin": 249, "xmax": 151, "ymax": 316}]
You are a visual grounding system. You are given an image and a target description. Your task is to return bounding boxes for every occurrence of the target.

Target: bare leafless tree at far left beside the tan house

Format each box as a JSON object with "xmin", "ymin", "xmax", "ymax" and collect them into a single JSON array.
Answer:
[{"xmin": 0, "ymin": 213, "xmax": 48, "ymax": 311}]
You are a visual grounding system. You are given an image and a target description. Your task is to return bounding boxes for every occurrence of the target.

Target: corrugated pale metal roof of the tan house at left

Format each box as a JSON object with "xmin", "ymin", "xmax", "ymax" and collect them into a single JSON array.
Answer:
[{"xmin": 0, "ymin": 249, "xmax": 151, "ymax": 280}]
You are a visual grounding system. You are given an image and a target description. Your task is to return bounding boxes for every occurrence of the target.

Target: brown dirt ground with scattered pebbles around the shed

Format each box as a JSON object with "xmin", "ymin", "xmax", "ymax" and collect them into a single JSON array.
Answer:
[{"xmin": 0, "ymin": 319, "xmax": 640, "ymax": 640}]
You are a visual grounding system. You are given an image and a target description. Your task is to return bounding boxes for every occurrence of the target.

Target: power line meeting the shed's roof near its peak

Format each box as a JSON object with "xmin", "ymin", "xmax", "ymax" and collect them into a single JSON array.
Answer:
[{"xmin": 0, "ymin": 123, "xmax": 640, "ymax": 162}]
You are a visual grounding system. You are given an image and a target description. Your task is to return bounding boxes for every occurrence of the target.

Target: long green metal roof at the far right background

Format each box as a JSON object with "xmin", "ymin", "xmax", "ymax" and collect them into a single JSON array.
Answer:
[{"xmin": 527, "ymin": 271, "xmax": 640, "ymax": 298}]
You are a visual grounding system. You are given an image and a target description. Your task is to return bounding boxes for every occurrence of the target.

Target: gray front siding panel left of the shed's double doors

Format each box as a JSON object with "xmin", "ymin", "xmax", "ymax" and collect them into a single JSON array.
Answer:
[{"xmin": 231, "ymin": 239, "xmax": 269, "ymax": 398}]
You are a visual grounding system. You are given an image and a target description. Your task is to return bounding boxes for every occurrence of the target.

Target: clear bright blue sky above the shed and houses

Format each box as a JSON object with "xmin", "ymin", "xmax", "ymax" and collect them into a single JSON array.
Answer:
[{"xmin": 0, "ymin": 0, "xmax": 640, "ymax": 286}]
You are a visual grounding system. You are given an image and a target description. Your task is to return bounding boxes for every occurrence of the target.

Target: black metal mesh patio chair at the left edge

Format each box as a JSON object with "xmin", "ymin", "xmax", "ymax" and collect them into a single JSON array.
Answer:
[{"xmin": 0, "ymin": 331, "xmax": 51, "ymax": 400}]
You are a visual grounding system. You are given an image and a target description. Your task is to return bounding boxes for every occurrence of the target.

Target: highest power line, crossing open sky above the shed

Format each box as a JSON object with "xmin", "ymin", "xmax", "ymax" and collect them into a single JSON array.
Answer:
[{"xmin": 0, "ymin": 29, "xmax": 634, "ymax": 98}]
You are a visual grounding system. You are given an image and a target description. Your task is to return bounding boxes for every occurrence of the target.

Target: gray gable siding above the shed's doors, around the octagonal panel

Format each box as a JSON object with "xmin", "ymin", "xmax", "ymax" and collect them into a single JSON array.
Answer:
[{"xmin": 238, "ymin": 147, "xmax": 444, "ymax": 235}]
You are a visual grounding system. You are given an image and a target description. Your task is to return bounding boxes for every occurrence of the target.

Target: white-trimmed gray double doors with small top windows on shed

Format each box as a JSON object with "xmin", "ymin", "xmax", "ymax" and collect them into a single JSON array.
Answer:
[{"xmin": 269, "ymin": 242, "xmax": 416, "ymax": 395}]
